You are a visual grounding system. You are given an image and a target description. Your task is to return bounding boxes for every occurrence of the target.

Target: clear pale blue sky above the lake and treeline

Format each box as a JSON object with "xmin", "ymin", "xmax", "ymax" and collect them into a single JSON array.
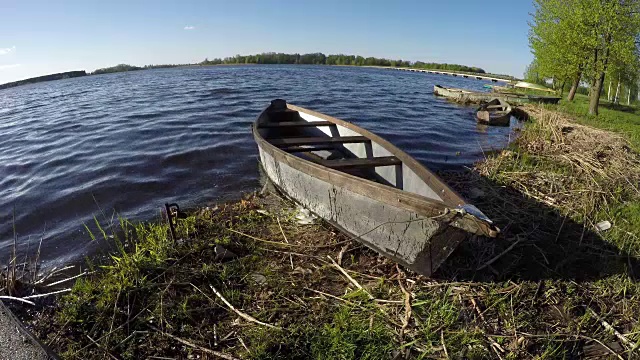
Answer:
[{"xmin": 0, "ymin": 0, "xmax": 533, "ymax": 83}]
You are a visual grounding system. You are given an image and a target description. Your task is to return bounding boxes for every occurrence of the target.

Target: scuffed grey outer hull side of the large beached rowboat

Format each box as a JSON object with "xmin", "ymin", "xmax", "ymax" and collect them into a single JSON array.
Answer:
[{"xmin": 258, "ymin": 145, "xmax": 467, "ymax": 276}]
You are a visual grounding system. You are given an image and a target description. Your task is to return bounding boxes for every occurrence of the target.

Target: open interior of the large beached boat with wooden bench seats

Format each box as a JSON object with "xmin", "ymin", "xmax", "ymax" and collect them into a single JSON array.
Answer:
[{"xmin": 257, "ymin": 103, "xmax": 442, "ymax": 201}]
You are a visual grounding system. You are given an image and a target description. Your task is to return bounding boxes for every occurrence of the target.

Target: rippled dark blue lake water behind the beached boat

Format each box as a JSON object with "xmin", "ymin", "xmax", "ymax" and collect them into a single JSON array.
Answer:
[{"xmin": 0, "ymin": 66, "xmax": 516, "ymax": 266}]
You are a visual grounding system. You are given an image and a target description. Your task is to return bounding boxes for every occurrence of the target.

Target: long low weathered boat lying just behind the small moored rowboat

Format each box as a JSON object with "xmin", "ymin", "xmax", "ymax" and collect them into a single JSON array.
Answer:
[{"xmin": 433, "ymin": 85, "xmax": 560, "ymax": 104}]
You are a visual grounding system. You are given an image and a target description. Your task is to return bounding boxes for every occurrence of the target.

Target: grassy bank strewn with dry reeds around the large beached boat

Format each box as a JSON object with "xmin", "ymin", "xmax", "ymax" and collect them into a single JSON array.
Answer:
[{"xmin": 11, "ymin": 102, "xmax": 640, "ymax": 359}]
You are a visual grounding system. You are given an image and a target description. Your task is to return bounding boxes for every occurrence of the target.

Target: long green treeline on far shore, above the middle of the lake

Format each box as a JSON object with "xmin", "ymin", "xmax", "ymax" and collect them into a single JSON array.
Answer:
[{"xmin": 200, "ymin": 52, "xmax": 485, "ymax": 74}]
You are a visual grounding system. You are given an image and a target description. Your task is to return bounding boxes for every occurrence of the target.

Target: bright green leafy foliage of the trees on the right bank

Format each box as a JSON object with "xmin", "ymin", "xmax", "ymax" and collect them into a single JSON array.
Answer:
[{"xmin": 529, "ymin": 0, "xmax": 640, "ymax": 114}]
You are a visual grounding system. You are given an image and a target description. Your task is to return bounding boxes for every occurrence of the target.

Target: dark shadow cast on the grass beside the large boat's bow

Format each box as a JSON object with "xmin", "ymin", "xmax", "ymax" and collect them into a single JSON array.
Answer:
[{"xmin": 435, "ymin": 171, "xmax": 640, "ymax": 283}]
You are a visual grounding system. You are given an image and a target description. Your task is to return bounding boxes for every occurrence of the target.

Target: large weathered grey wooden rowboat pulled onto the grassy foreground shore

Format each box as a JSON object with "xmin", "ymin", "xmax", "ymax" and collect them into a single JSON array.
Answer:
[{"xmin": 253, "ymin": 99, "xmax": 499, "ymax": 276}]
